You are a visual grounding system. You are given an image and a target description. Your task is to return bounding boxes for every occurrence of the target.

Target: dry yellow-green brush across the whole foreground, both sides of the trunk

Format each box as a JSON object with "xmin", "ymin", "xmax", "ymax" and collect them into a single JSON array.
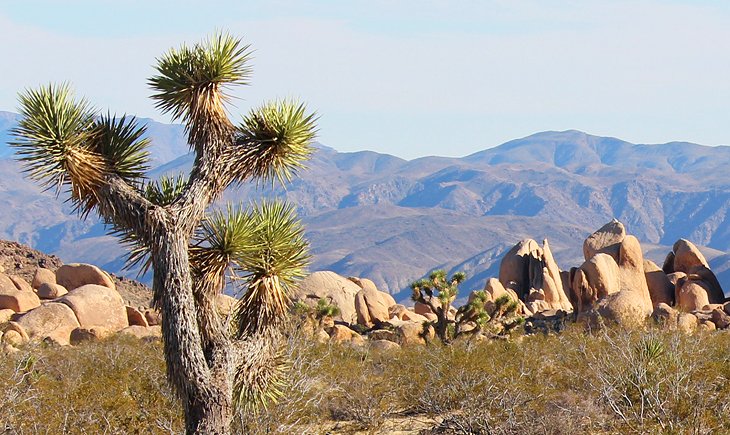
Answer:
[{"xmin": 0, "ymin": 328, "xmax": 730, "ymax": 434}]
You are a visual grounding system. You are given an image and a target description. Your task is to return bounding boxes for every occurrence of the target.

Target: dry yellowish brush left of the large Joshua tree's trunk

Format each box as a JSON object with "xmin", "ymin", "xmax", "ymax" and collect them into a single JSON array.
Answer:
[{"xmin": 0, "ymin": 336, "xmax": 183, "ymax": 434}]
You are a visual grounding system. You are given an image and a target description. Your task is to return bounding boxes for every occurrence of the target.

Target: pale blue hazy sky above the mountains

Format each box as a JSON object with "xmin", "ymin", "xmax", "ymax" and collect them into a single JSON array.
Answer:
[{"xmin": 0, "ymin": 0, "xmax": 730, "ymax": 158}]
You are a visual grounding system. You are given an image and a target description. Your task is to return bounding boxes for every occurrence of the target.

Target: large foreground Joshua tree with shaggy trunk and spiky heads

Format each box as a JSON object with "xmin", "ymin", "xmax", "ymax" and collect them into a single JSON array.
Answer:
[{"xmin": 13, "ymin": 34, "xmax": 315, "ymax": 434}]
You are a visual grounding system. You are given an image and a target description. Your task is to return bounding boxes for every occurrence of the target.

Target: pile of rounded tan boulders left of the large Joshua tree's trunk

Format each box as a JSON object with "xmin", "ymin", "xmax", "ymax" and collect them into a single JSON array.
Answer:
[{"xmin": 0, "ymin": 263, "xmax": 161, "ymax": 351}]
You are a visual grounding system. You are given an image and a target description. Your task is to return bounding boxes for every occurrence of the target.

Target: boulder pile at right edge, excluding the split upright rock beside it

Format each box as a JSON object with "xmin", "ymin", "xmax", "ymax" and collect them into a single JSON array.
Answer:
[{"xmin": 570, "ymin": 220, "xmax": 730, "ymax": 331}]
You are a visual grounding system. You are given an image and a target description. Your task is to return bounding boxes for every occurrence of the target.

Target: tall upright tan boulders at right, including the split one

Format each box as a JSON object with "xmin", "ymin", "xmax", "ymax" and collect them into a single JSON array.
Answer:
[{"xmin": 494, "ymin": 219, "xmax": 730, "ymax": 331}]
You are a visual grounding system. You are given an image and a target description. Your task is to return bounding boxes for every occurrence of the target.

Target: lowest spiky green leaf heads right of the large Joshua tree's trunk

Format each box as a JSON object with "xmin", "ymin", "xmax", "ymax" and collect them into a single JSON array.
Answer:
[{"xmin": 191, "ymin": 201, "xmax": 309, "ymax": 338}]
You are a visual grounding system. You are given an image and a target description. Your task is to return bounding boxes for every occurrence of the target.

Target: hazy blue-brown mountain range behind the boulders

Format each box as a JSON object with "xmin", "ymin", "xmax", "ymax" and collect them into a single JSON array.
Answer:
[{"xmin": 0, "ymin": 112, "xmax": 730, "ymax": 304}]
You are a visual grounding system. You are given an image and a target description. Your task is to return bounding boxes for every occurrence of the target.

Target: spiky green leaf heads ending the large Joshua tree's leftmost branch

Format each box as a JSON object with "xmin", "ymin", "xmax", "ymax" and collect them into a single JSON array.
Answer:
[{"xmin": 10, "ymin": 84, "xmax": 149, "ymax": 216}]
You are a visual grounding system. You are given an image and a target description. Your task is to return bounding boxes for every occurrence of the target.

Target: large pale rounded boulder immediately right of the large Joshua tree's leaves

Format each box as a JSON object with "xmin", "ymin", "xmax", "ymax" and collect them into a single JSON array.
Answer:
[{"xmin": 290, "ymin": 271, "xmax": 360, "ymax": 323}]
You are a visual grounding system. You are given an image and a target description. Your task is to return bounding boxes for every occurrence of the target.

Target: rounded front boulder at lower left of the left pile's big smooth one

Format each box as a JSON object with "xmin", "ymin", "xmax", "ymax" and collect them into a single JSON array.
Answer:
[{"xmin": 17, "ymin": 302, "xmax": 79, "ymax": 345}]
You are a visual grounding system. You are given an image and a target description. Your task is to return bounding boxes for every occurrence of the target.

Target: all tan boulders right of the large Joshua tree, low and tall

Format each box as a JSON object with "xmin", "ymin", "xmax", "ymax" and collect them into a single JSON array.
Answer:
[{"xmin": 293, "ymin": 219, "xmax": 730, "ymax": 349}]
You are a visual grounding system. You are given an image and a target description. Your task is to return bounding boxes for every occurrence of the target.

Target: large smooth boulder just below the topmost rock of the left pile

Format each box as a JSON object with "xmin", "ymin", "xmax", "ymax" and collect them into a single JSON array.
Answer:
[{"xmin": 58, "ymin": 284, "xmax": 129, "ymax": 332}]
